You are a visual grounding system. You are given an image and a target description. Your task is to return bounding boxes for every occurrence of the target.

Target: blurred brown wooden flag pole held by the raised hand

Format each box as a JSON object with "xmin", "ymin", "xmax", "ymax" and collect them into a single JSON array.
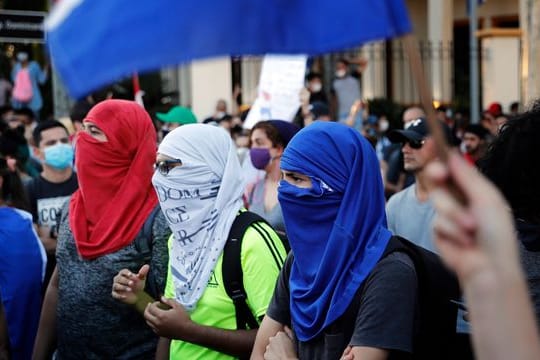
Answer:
[{"xmin": 401, "ymin": 34, "xmax": 449, "ymax": 162}]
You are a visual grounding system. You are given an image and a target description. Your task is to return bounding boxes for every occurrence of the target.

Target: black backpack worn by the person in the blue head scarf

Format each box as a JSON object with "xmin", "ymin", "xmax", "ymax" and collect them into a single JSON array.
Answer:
[{"xmin": 382, "ymin": 236, "xmax": 472, "ymax": 359}]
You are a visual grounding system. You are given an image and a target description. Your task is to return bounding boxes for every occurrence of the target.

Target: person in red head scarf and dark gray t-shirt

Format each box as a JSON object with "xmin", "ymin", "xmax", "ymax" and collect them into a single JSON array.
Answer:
[{"xmin": 34, "ymin": 100, "xmax": 170, "ymax": 359}]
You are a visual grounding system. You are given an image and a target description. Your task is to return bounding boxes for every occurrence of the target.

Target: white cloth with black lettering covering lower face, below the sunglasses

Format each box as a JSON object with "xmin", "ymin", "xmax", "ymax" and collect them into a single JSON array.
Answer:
[{"xmin": 152, "ymin": 165, "xmax": 220, "ymax": 311}]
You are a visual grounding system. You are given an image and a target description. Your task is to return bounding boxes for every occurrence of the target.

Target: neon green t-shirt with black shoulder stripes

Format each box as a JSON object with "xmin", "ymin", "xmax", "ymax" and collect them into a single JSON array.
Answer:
[{"xmin": 165, "ymin": 218, "xmax": 287, "ymax": 360}]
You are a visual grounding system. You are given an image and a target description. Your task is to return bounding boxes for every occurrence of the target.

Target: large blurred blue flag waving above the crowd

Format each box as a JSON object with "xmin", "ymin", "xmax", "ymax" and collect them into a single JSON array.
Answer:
[{"xmin": 46, "ymin": 0, "xmax": 411, "ymax": 97}]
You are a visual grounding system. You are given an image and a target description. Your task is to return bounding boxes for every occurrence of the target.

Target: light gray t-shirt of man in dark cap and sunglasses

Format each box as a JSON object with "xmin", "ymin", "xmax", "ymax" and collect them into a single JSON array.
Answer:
[{"xmin": 386, "ymin": 184, "xmax": 437, "ymax": 253}]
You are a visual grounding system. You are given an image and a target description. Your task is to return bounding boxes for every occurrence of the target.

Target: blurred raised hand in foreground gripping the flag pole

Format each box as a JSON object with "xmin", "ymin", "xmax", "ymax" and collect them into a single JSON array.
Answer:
[{"xmin": 428, "ymin": 153, "xmax": 518, "ymax": 279}]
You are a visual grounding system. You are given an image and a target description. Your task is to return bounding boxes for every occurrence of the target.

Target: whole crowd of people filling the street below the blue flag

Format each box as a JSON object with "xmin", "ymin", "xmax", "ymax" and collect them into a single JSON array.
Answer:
[{"xmin": 0, "ymin": 54, "xmax": 540, "ymax": 360}]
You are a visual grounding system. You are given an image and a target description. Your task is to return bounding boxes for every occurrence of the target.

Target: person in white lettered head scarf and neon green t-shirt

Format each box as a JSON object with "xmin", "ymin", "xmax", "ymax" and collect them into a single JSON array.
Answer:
[{"xmin": 113, "ymin": 124, "xmax": 285, "ymax": 359}]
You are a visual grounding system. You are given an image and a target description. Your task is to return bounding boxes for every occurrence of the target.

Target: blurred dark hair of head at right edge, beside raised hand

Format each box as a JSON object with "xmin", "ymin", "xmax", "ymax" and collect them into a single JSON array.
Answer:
[{"xmin": 480, "ymin": 102, "xmax": 540, "ymax": 224}]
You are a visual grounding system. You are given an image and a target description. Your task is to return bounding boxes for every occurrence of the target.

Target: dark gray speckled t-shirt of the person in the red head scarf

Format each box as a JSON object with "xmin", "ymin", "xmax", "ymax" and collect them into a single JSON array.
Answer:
[{"xmin": 56, "ymin": 206, "xmax": 171, "ymax": 359}]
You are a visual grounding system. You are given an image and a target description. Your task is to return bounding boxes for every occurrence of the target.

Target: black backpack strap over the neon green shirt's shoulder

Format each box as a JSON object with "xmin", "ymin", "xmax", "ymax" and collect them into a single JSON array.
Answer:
[{"xmin": 222, "ymin": 211, "xmax": 266, "ymax": 330}]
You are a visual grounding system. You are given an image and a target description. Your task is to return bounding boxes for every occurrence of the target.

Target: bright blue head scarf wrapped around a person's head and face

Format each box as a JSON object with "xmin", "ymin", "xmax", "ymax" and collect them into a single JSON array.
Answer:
[{"xmin": 278, "ymin": 122, "xmax": 391, "ymax": 341}]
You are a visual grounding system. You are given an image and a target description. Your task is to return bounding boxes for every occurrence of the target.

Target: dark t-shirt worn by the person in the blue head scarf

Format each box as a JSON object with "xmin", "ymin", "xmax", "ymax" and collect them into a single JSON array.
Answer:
[{"xmin": 266, "ymin": 245, "xmax": 418, "ymax": 360}]
